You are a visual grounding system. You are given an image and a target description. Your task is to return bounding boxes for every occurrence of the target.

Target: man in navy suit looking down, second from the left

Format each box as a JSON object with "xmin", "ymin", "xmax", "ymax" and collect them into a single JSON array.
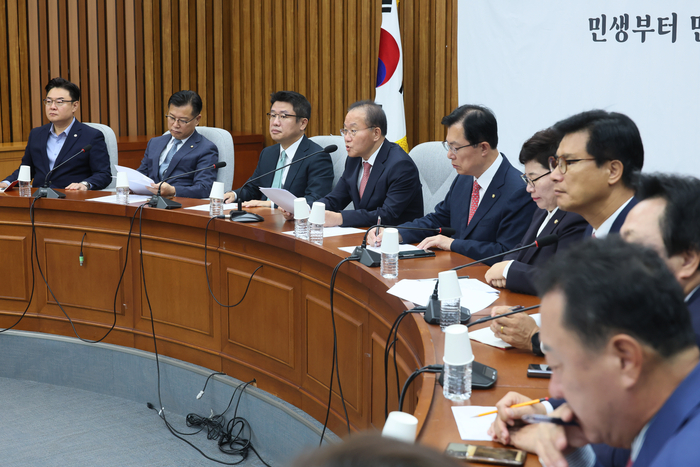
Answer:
[{"xmin": 138, "ymin": 91, "xmax": 219, "ymax": 198}]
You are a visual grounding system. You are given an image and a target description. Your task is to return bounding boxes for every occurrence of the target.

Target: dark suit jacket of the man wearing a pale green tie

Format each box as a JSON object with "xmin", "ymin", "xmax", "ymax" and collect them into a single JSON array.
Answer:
[{"xmin": 234, "ymin": 136, "xmax": 333, "ymax": 205}]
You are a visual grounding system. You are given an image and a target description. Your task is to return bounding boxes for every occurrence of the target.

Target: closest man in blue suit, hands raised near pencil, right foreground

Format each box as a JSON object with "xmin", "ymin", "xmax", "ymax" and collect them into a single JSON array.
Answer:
[{"xmin": 491, "ymin": 236, "xmax": 700, "ymax": 467}]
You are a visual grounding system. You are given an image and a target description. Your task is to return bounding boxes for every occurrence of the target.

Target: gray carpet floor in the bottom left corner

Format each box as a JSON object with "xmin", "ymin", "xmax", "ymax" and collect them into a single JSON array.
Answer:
[{"xmin": 0, "ymin": 378, "xmax": 272, "ymax": 467}]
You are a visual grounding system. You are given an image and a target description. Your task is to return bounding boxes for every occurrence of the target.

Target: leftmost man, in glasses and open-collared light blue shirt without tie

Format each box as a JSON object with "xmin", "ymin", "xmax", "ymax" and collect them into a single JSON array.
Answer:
[{"xmin": 0, "ymin": 78, "xmax": 112, "ymax": 190}]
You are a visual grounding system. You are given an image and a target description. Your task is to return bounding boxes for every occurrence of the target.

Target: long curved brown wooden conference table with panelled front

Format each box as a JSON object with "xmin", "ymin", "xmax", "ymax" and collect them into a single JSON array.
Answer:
[{"xmin": 0, "ymin": 190, "xmax": 547, "ymax": 465}]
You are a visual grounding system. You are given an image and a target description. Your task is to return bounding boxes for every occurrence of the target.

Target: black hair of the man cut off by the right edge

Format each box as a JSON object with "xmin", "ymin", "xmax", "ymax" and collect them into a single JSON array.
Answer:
[{"xmin": 636, "ymin": 173, "xmax": 700, "ymax": 257}]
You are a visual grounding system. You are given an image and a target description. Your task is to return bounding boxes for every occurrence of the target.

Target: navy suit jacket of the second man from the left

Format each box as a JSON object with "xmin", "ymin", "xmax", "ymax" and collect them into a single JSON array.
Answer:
[{"xmin": 138, "ymin": 130, "xmax": 219, "ymax": 198}]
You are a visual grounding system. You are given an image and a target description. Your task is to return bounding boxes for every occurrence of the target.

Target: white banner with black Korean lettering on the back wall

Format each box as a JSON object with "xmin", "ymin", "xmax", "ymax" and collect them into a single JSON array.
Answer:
[{"xmin": 458, "ymin": 0, "xmax": 700, "ymax": 177}]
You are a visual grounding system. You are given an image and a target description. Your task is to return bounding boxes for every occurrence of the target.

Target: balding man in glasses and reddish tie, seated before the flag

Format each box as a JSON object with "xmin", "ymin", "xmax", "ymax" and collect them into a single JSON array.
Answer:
[{"xmin": 319, "ymin": 101, "xmax": 423, "ymax": 227}]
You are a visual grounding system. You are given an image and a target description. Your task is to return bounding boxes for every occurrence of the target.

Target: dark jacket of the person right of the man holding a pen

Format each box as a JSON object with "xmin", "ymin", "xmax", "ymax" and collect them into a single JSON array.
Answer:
[{"xmin": 503, "ymin": 209, "xmax": 588, "ymax": 295}]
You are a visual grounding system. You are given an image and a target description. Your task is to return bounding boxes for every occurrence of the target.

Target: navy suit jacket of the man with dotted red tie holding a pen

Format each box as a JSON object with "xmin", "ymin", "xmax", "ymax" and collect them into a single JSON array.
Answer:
[{"xmin": 400, "ymin": 154, "xmax": 537, "ymax": 265}]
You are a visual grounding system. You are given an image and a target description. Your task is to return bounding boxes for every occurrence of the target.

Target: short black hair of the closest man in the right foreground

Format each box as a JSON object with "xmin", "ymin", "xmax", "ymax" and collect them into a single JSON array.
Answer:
[{"xmin": 536, "ymin": 235, "xmax": 696, "ymax": 358}]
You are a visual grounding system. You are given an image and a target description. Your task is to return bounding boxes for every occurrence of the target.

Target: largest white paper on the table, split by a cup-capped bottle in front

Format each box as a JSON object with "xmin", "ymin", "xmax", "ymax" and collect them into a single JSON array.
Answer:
[{"xmin": 388, "ymin": 279, "xmax": 499, "ymax": 313}]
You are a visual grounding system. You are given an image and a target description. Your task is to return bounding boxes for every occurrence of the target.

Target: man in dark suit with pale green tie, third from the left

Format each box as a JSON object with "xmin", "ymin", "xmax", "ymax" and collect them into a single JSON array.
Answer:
[{"xmin": 224, "ymin": 91, "xmax": 333, "ymax": 207}]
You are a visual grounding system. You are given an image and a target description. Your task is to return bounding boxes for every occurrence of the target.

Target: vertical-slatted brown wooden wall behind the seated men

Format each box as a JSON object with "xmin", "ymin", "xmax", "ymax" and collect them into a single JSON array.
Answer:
[{"xmin": 5, "ymin": 0, "xmax": 458, "ymax": 147}]
